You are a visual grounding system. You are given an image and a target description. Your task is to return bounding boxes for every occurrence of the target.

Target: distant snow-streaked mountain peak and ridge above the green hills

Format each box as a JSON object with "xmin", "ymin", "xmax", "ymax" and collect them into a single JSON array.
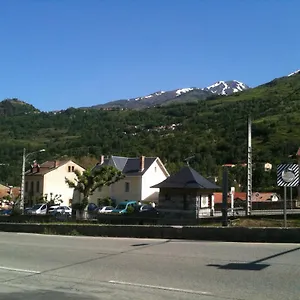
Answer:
[{"xmin": 92, "ymin": 80, "xmax": 249, "ymax": 109}]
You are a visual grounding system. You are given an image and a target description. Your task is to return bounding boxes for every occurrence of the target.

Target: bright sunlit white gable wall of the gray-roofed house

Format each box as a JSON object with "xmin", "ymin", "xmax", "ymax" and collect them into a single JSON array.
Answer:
[{"xmin": 141, "ymin": 159, "xmax": 168, "ymax": 203}]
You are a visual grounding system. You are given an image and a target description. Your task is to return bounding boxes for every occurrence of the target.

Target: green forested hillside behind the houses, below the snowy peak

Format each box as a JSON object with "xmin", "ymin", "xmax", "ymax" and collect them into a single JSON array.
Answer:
[{"xmin": 0, "ymin": 74, "xmax": 300, "ymax": 190}]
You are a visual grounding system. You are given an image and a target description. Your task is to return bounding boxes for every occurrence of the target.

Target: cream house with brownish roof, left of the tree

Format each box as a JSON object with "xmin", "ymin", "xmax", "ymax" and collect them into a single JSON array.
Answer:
[{"xmin": 24, "ymin": 160, "xmax": 84, "ymax": 206}]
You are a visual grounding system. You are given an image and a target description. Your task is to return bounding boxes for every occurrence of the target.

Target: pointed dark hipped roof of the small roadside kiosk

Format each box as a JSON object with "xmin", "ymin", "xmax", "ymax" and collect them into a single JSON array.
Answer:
[{"xmin": 152, "ymin": 166, "xmax": 220, "ymax": 190}]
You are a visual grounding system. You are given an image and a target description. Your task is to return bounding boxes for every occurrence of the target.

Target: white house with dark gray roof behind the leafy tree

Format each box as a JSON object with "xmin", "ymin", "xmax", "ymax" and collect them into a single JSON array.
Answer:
[{"xmin": 89, "ymin": 155, "xmax": 169, "ymax": 204}]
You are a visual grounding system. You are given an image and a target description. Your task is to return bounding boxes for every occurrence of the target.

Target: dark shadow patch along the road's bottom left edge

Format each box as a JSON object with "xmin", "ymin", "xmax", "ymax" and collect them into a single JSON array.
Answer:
[{"xmin": 0, "ymin": 290, "xmax": 99, "ymax": 300}]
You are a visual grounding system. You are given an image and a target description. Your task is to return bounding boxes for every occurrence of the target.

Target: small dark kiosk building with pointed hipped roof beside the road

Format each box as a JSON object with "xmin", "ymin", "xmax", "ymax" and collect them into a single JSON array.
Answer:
[{"xmin": 153, "ymin": 166, "xmax": 220, "ymax": 219}]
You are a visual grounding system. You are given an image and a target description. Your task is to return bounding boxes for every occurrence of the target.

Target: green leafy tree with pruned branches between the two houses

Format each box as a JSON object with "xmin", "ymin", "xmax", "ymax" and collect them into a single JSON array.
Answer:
[{"xmin": 65, "ymin": 166, "xmax": 124, "ymax": 212}]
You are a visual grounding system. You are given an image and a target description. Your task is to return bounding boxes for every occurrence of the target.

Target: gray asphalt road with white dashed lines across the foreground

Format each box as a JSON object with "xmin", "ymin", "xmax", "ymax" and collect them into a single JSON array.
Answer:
[{"xmin": 0, "ymin": 232, "xmax": 300, "ymax": 300}]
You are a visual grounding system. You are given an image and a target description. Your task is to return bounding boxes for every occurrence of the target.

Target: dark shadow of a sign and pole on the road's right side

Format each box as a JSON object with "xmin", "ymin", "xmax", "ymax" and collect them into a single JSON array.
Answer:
[{"xmin": 207, "ymin": 247, "xmax": 300, "ymax": 271}]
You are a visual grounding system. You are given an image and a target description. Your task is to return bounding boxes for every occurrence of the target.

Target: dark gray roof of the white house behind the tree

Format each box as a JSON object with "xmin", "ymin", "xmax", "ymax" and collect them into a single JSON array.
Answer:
[{"xmin": 95, "ymin": 156, "xmax": 157, "ymax": 176}]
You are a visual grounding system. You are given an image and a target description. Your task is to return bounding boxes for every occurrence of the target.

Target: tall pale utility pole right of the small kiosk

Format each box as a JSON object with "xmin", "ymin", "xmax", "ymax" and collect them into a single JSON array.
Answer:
[{"xmin": 246, "ymin": 116, "xmax": 252, "ymax": 216}]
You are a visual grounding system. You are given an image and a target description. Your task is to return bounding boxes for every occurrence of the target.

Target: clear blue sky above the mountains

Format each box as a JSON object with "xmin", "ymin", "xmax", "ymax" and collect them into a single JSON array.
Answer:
[{"xmin": 0, "ymin": 0, "xmax": 300, "ymax": 111}]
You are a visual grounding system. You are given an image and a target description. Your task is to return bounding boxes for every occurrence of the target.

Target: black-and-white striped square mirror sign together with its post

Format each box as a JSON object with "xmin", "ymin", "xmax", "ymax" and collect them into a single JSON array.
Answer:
[{"xmin": 277, "ymin": 164, "xmax": 299, "ymax": 227}]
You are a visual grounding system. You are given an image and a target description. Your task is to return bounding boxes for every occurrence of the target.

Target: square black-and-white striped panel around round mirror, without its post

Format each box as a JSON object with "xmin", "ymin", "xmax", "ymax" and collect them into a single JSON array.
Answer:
[{"xmin": 277, "ymin": 164, "xmax": 299, "ymax": 187}]
